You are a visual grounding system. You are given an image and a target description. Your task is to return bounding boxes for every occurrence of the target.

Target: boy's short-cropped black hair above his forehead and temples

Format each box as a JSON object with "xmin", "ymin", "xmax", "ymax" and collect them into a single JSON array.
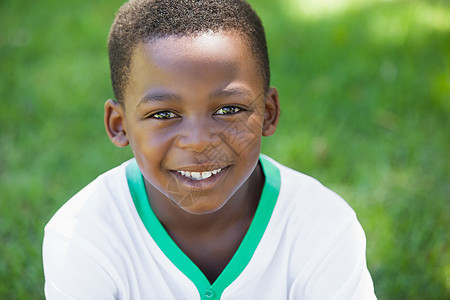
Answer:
[{"xmin": 108, "ymin": 0, "xmax": 270, "ymax": 104}]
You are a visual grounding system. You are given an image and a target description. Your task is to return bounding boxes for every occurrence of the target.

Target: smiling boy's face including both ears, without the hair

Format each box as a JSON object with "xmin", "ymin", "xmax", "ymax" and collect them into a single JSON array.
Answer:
[{"xmin": 105, "ymin": 32, "xmax": 279, "ymax": 214}]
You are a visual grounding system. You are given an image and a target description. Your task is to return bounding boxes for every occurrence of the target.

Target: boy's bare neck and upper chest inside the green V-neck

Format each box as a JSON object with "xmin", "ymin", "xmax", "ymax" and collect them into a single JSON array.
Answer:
[{"xmin": 147, "ymin": 166, "xmax": 264, "ymax": 283}]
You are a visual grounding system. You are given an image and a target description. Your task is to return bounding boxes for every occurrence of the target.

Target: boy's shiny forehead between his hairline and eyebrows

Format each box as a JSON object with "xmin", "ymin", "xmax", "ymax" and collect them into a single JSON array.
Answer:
[{"xmin": 126, "ymin": 32, "xmax": 263, "ymax": 101}]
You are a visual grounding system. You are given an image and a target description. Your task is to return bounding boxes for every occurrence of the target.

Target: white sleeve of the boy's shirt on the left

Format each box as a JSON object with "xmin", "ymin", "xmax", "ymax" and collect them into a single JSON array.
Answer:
[{"xmin": 43, "ymin": 228, "xmax": 119, "ymax": 300}]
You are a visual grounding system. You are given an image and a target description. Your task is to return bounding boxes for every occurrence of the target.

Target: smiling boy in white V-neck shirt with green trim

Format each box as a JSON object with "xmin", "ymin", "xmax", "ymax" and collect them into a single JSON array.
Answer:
[{"xmin": 43, "ymin": 0, "xmax": 375, "ymax": 299}]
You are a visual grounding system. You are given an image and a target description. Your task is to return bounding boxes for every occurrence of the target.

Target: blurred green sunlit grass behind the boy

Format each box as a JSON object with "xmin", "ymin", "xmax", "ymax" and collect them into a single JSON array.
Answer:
[{"xmin": 0, "ymin": 0, "xmax": 450, "ymax": 299}]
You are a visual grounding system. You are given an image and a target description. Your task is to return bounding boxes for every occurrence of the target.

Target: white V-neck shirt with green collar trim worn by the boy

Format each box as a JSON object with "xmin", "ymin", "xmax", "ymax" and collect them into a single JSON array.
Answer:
[{"xmin": 43, "ymin": 156, "xmax": 376, "ymax": 300}]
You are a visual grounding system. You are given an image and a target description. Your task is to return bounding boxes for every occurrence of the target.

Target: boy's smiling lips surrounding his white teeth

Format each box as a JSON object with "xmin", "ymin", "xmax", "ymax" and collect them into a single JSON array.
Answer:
[{"xmin": 170, "ymin": 166, "xmax": 230, "ymax": 191}]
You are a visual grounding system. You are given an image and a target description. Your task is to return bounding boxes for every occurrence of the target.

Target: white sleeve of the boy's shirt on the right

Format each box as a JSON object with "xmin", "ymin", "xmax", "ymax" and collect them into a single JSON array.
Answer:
[{"xmin": 289, "ymin": 217, "xmax": 376, "ymax": 300}]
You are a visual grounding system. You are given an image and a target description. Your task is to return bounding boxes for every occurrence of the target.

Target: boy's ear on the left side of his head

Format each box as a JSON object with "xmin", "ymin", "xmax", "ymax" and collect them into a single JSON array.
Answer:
[{"xmin": 105, "ymin": 99, "xmax": 129, "ymax": 147}]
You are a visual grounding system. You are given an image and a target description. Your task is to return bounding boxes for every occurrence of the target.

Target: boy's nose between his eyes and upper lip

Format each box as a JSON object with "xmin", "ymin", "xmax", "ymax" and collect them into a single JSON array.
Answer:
[{"xmin": 176, "ymin": 118, "xmax": 220, "ymax": 153}]
